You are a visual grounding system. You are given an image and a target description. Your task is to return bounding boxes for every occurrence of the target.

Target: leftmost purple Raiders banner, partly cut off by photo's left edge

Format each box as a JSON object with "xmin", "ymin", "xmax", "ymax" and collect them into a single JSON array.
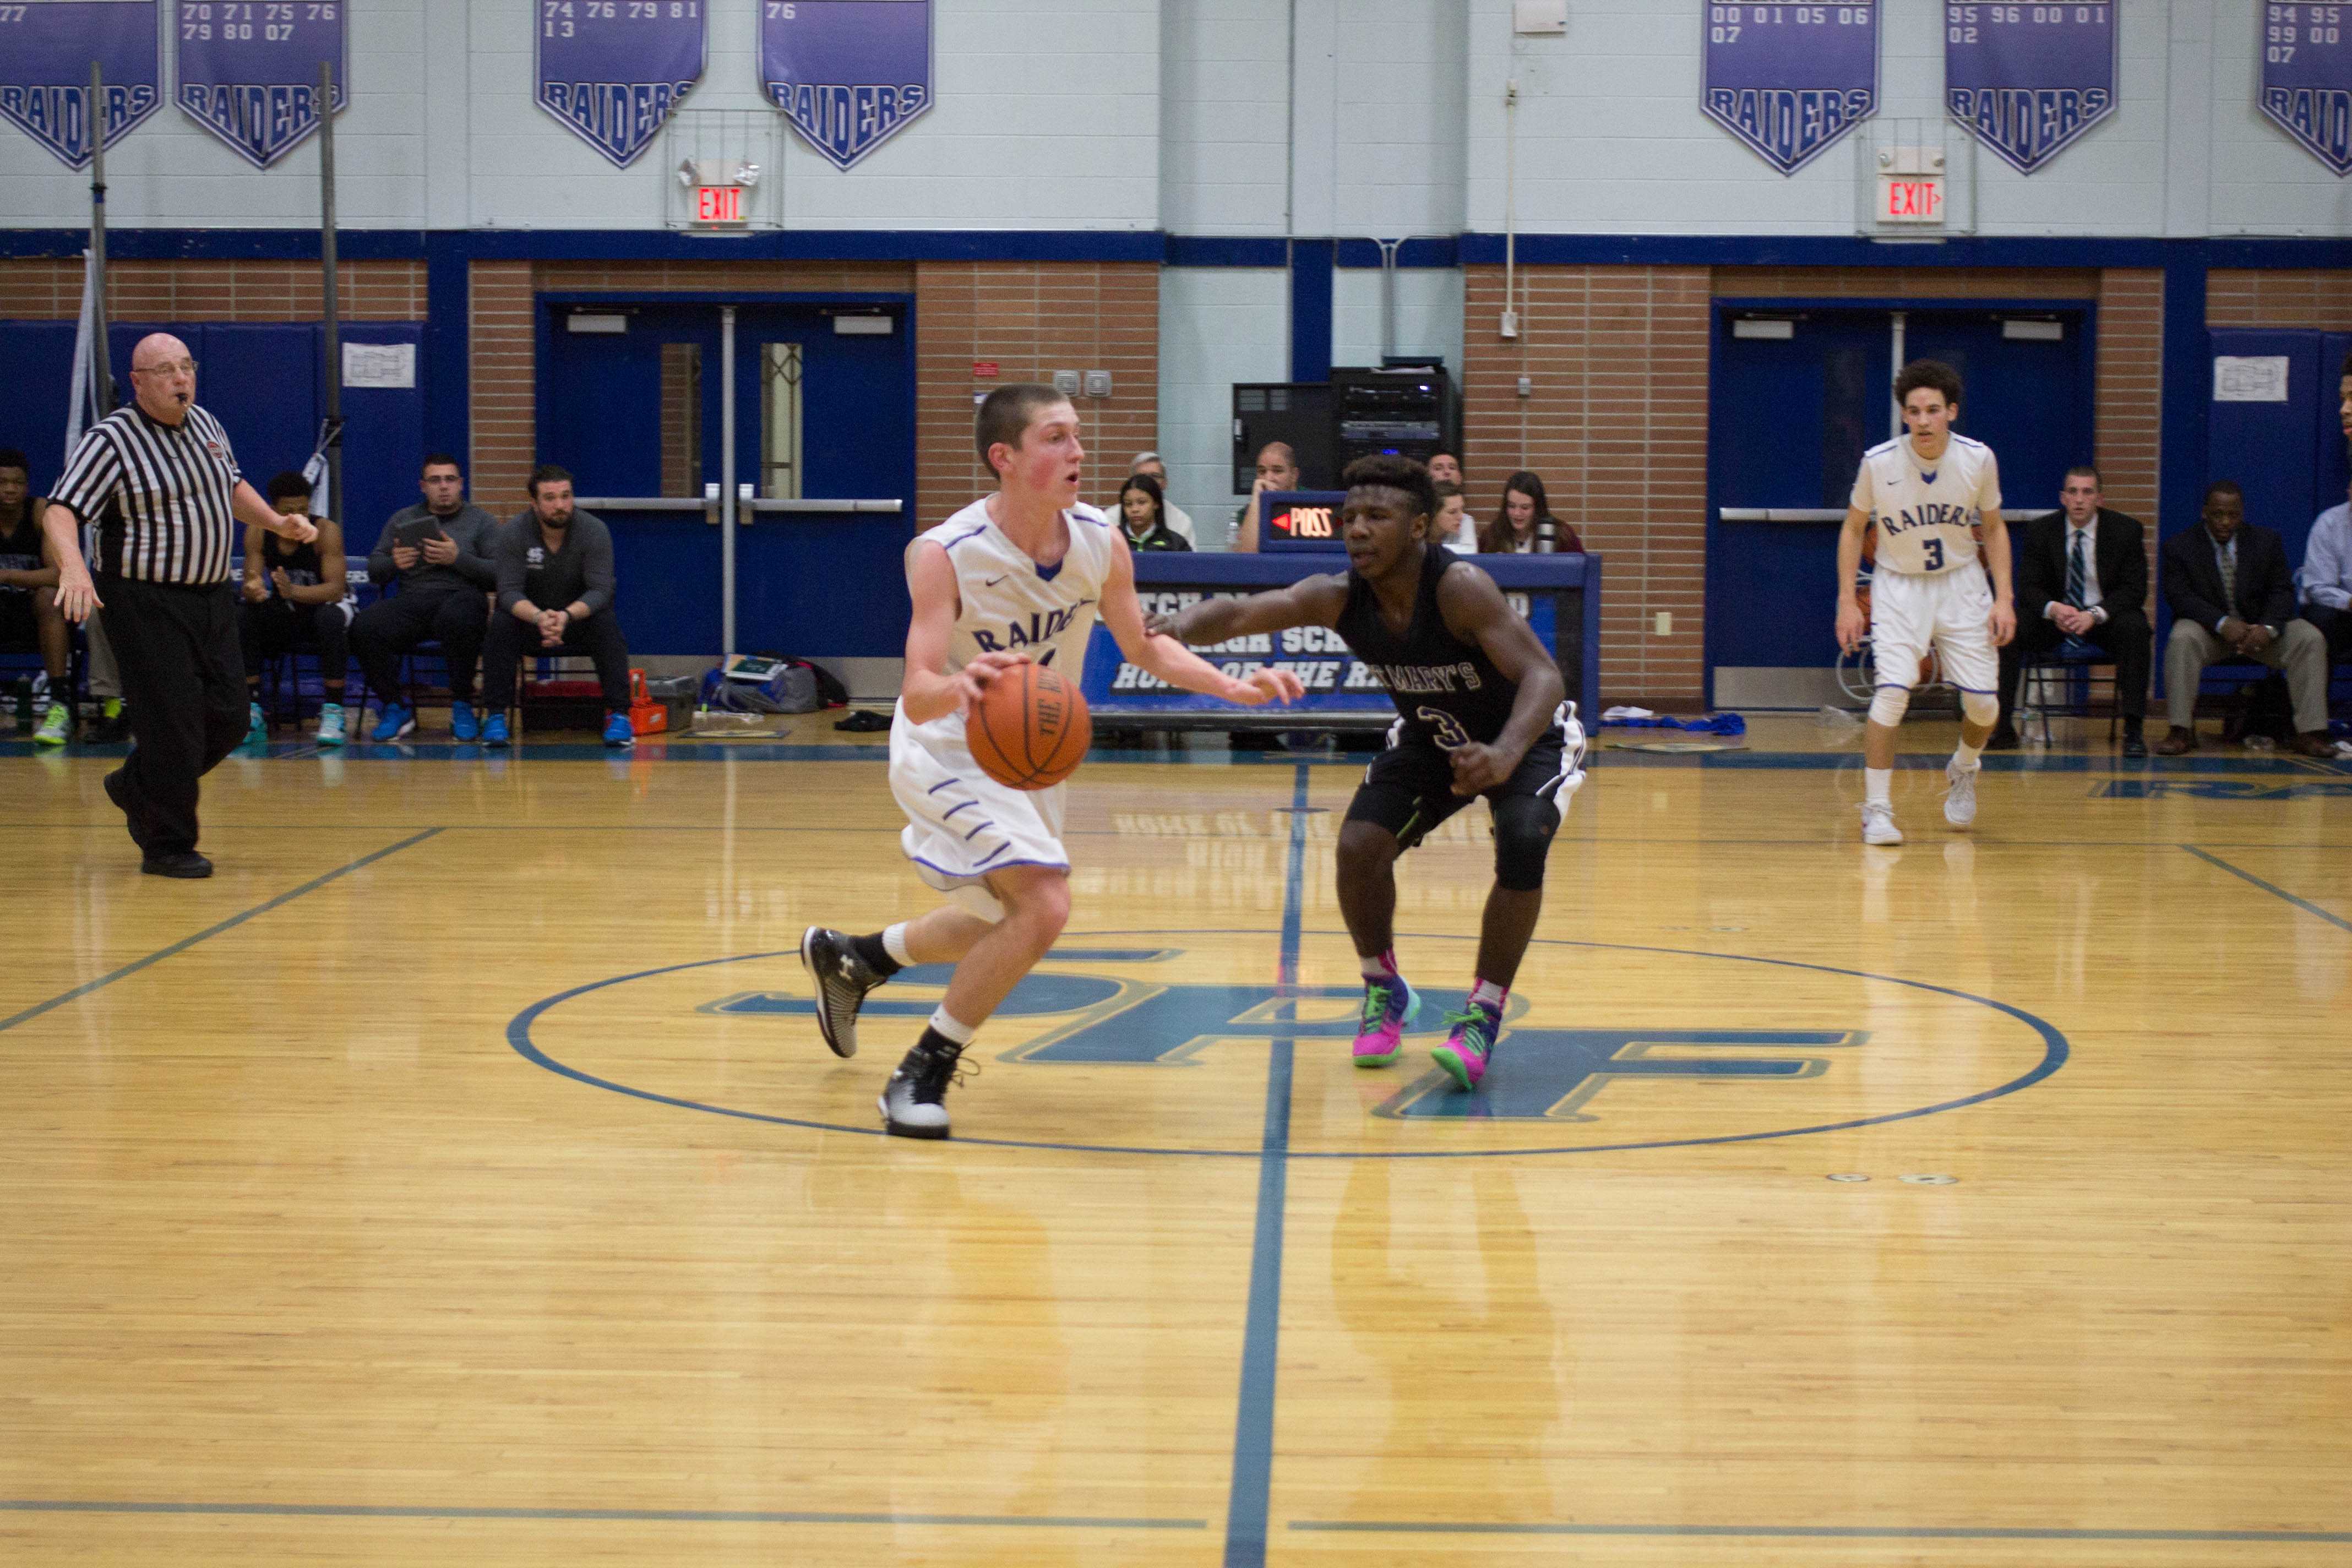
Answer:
[{"xmin": 0, "ymin": 0, "xmax": 162, "ymax": 169}]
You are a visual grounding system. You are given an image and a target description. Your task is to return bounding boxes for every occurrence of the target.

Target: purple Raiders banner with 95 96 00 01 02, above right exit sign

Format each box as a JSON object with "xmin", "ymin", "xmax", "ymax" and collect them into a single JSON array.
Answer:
[{"xmin": 1943, "ymin": 0, "xmax": 2117, "ymax": 174}]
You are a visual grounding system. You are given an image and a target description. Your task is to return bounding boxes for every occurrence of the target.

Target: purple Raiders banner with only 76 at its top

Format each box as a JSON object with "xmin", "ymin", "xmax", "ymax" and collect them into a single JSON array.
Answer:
[{"xmin": 760, "ymin": 0, "xmax": 932, "ymax": 169}]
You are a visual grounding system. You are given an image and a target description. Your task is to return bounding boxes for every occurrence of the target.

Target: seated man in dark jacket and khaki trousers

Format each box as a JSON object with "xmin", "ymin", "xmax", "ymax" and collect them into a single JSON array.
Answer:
[{"xmin": 2157, "ymin": 480, "xmax": 2335, "ymax": 757}]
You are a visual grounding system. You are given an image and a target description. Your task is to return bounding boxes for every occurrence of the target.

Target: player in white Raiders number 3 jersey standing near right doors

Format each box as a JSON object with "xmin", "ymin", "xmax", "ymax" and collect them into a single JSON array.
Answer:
[{"xmin": 1837, "ymin": 360, "xmax": 2018, "ymax": 844}]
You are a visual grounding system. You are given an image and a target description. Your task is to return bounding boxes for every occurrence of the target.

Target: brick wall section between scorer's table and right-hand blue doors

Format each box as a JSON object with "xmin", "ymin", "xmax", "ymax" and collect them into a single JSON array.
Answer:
[{"xmin": 1463, "ymin": 265, "xmax": 1707, "ymax": 707}]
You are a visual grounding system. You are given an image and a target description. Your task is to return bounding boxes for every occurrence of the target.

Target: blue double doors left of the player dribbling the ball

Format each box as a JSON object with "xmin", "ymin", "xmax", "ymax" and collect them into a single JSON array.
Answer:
[{"xmin": 538, "ymin": 296, "xmax": 915, "ymax": 658}]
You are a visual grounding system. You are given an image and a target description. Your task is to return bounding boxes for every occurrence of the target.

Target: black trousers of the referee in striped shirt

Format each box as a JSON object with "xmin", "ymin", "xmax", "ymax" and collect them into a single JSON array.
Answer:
[{"xmin": 99, "ymin": 578, "xmax": 244, "ymax": 856}]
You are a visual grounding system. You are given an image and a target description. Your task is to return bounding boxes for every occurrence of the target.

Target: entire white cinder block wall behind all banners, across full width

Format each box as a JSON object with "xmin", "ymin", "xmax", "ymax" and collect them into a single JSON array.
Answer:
[{"xmin": 0, "ymin": 0, "xmax": 2352, "ymax": 235}]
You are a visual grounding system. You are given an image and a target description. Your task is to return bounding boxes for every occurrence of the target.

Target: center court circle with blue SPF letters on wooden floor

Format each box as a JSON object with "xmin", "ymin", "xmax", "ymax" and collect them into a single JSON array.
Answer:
[{"xmin": 508, "ymin": 929, "xmax": 2067, "ymax": 1159}]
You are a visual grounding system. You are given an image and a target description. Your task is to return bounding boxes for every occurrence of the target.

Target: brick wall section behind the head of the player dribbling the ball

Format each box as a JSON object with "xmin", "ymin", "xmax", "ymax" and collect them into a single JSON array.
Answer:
[{"xmin": 915, "ymin": 261, "xmax": 1159, "ymax": 529}]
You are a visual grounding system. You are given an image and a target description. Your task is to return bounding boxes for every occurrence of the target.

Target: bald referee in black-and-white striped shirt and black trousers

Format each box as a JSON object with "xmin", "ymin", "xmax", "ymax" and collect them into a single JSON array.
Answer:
[{"xmin": 40, "ymin": 331, "xmax": 318, "ymax": 877}]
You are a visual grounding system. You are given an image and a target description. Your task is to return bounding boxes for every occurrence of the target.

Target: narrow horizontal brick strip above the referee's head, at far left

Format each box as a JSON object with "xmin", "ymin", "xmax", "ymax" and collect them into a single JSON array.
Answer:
[{"xmin": 0, "ymin": 259, "xmax": 426, "ymax": 322}]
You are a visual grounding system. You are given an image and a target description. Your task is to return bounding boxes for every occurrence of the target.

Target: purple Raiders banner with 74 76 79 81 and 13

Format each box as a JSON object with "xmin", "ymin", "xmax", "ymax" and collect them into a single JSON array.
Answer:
[{"xmin": 536, "ymin": 0, "xmax": 706, "ymax": 169}]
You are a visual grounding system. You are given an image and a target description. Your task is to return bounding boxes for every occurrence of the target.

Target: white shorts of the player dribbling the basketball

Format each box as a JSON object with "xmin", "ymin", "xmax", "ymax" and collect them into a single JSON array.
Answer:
[{"xmin": 889, "ymin": 707, "xmax": 1070, "ymax": 919}]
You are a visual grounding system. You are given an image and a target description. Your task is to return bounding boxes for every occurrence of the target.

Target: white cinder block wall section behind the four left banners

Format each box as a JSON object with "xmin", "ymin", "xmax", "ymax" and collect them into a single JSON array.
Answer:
[{"xmin": 0, "ymin": 0, "xmax": 1162, "ymax": 230}]
